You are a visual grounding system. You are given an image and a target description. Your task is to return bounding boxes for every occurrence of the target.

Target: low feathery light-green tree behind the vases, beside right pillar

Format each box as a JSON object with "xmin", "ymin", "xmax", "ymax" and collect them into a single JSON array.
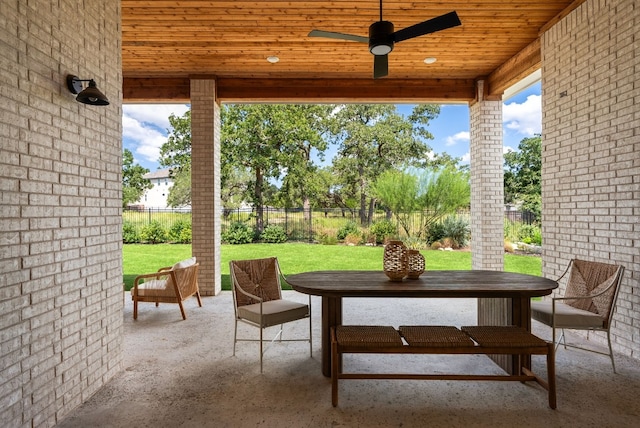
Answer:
[{"xmin": 374, "ymin": 166, "xmax": 471, "ymax": 237}]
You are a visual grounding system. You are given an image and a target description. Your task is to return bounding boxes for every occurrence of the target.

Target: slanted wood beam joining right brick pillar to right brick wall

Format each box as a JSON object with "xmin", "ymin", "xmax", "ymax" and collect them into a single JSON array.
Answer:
[{"xmin": 485, "ymin": 38, "xmax": 542, "ymax": 100}]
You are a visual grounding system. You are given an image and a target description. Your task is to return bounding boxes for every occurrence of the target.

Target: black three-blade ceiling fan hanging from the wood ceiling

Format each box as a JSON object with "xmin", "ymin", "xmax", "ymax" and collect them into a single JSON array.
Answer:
[{"xmin": 309, "ymin": 0, "xmax": 462, "ymax": 79}]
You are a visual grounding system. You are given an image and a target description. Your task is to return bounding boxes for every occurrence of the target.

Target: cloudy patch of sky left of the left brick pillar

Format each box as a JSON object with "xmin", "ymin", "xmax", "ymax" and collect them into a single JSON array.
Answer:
[{"xmin": 122, "ymin": 104, "xmax": 189, "ymax": 163}]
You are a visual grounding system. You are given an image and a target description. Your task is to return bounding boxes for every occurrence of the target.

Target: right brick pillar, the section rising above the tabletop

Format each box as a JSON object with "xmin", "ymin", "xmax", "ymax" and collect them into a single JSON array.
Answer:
[{"xmin": 469, "ymin": 81, "xmax": 504, "ymax": 270}]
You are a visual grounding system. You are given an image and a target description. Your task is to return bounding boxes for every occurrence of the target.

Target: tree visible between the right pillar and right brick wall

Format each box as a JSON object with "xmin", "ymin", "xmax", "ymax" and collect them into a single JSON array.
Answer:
[{"xmin": 504, "ymin": 135, "xmax": 542, "ymax": 219}]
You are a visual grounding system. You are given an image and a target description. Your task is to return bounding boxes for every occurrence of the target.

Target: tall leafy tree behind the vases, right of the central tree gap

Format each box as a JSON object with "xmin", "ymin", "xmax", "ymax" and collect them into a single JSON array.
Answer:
[{"xmin": 331, "ymin": 104, "xmax": 440, "ymax": 224}]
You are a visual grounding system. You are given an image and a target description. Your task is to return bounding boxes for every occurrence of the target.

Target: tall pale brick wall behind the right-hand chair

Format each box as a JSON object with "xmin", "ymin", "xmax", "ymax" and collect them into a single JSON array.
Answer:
[{"xmin": 542, "ymin": 0, "xmax": 640, "ymax": 358}]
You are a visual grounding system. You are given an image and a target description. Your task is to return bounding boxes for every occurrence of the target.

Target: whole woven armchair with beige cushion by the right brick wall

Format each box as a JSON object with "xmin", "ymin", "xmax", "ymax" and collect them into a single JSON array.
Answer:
[{"xmin": 531, "ymin": 259, "xmax": 624, "ymax": 373}]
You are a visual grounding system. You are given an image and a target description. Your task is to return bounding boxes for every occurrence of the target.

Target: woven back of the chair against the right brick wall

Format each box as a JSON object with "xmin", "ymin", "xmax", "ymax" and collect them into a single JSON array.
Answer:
[{"xmin": 565, "ymin": 259, "xmax": 620, "ymax": 320}]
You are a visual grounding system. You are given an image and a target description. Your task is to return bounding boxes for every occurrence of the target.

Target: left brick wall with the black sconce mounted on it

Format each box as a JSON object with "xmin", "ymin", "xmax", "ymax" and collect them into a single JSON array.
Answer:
[{"xmin": 0, "ymin": 0, "xmax": 122, "ymax": 427}]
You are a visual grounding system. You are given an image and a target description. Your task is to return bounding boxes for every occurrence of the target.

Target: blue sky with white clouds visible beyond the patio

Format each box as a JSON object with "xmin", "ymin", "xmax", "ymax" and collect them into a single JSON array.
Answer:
[{"xmin": 122, "ymin": 82, "xmax": 542, "ymax": 171}]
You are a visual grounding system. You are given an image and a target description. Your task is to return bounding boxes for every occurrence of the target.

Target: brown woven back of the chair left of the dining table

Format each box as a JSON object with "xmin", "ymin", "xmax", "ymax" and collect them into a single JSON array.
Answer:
[{"xmin": 231, "ymin": 257, "xmax": 282, "ymax": 306}]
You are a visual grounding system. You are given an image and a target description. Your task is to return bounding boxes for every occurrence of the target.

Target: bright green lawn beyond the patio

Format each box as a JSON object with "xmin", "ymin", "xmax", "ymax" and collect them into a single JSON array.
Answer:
[{"xmin": 122, "ymin": 243, "xmax": 542, "ymax": 290}]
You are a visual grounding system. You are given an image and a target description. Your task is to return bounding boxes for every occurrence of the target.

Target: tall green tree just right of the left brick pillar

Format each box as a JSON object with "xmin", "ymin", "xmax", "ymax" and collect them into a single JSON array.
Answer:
[{"xmin": 222, "ymin": 104, "xmax": 329, "ymax": 233}]
